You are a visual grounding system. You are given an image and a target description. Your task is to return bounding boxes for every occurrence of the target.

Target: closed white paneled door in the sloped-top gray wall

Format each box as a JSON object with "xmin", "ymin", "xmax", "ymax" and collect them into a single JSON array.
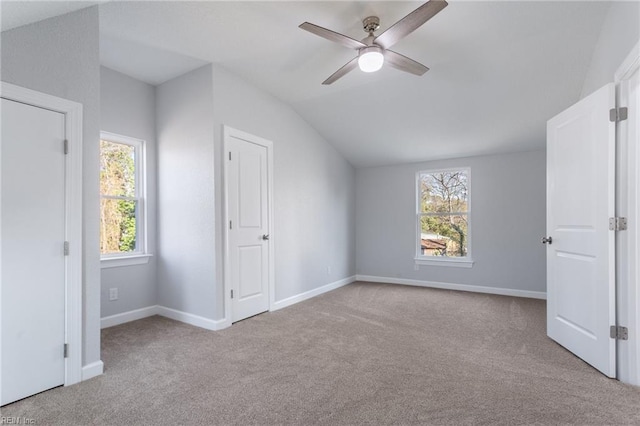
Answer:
[{"xmin": 225, "ymin": 130, "xmax": 271, "ymax": 322}]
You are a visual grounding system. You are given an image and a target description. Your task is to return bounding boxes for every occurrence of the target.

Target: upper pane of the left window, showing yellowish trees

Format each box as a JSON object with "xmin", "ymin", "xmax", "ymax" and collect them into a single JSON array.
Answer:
[{"xmin": 100, "ymin": 140, "xmax": 136, "ymax": 197}]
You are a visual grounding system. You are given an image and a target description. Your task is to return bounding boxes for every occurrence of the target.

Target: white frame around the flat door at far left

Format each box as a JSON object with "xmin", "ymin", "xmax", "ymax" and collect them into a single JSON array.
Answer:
[{"xmin": 0, "ymin": 81, "xmax": 82, "ymax": 392}]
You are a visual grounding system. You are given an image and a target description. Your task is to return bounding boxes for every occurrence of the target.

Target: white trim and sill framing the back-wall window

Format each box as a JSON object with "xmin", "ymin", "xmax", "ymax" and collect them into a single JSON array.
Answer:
[{"xmin": 414, "ymin": 166, "xmax": 475, "ymax": 268}]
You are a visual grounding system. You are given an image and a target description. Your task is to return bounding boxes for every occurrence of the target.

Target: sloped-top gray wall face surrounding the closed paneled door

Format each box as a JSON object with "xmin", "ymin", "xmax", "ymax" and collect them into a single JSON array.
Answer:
[{"xmin": 213, "ymin": 67, "xmax": 355, "ymax": 312}]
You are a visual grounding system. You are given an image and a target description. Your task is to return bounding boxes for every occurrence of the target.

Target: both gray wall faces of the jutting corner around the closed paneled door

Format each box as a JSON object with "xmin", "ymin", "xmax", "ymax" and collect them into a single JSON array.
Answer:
[{"xmin": 156, "ymin": 66, "xmax": 355, "ymax": 319}]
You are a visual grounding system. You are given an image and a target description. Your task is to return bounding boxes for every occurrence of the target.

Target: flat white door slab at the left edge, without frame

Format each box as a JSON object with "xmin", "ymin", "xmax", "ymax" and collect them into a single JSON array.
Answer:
[{"xmin": 0, "ymin": 99, "xmax": 65, "ymax": 405}]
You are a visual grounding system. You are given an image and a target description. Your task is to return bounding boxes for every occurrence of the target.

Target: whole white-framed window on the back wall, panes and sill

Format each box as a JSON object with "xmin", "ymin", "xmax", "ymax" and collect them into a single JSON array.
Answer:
[{"xmin": 416, "ymin": 169, "xmax": 473, "ymax": 267}]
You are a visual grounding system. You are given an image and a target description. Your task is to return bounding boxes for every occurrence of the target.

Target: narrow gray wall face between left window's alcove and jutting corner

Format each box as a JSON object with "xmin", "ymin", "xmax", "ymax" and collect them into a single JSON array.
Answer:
[{"xmin": 156, "ymin": 65, "xmax": 218, "ymax": 319}]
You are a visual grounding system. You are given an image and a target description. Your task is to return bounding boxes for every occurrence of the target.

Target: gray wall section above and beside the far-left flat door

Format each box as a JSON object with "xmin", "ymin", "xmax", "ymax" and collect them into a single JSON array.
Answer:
[{"xmin": 2, "ymin": 7, "xmax": 100, "ymax": 365}]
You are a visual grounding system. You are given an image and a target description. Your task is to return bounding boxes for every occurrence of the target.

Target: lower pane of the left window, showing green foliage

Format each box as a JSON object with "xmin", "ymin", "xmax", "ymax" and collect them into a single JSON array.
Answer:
[{"xmin": 100, "ymin": 198, "xmax": 138, "ymax": 254}]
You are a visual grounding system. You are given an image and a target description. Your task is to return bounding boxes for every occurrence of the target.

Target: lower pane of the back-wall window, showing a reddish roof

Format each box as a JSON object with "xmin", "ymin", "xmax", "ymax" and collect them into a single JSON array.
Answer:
[{"xmin": 420, "ymin": 214, "xmax": 467, "ymax": 257}]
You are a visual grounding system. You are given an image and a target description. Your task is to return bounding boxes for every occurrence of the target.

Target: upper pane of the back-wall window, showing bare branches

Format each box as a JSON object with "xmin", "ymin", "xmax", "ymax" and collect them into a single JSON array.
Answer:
[{"xmin": 419, "ymin": 171, "xmax": 469, "ymax": 213}]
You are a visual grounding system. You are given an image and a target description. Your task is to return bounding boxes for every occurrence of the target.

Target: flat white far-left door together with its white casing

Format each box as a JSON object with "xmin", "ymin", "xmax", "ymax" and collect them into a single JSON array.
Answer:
[{"xmin": 0, "ymin": 82, "xmax": 82, "ymax": 404}]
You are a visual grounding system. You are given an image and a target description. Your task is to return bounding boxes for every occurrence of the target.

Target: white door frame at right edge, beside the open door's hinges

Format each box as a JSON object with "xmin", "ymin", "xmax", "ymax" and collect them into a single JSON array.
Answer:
[{"xmin": 614, "ymin": 40, "xmax": 640, "ymax": 386}]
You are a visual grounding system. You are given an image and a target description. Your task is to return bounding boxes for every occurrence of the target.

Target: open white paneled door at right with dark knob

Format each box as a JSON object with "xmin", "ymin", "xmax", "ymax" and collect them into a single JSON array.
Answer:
[{"xmin": 547, "ymin": 84, "xmax": 616, "ymax": 377}]
